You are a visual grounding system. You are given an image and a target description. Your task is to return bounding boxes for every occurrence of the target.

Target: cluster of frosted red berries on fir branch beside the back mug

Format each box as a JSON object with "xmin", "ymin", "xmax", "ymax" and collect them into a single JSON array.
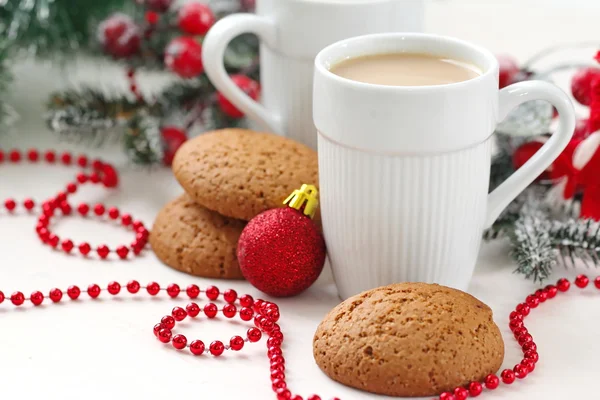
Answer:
[{"xmin": 98, "ymin": 0, "xmax": 260, "ymax": 165}]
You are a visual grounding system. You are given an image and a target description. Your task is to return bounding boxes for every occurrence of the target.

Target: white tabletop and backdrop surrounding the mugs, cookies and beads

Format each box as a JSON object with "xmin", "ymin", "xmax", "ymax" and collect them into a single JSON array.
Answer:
[{"xmin": 0, "ymin": 0, "xmax": 600, "ymax": 400}]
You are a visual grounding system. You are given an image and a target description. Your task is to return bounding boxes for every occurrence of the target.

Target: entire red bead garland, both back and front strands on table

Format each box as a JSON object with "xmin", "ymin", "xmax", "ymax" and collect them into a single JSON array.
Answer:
[{"xmin": 0, "ymin": 149, "xmax": 600, "ymax": 400}]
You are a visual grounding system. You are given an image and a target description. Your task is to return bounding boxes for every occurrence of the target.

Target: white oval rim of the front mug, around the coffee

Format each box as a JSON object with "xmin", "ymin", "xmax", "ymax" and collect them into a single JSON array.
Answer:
[{"xmin": 315, "ymin": 32, "xmax": 498, "ymax": 92}]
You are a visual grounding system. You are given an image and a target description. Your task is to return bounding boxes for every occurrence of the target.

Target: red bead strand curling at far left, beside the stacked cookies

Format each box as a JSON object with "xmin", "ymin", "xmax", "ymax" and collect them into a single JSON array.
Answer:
[{"xmin": 0, "ymin": 149, "xmax": 149, "ymax": 259}]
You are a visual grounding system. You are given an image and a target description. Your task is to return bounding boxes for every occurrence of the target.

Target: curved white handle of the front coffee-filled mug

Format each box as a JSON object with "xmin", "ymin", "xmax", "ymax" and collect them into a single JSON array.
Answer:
[{"xmin": 484, "ymin": 81, "xmax": 575, "ymax": 229}]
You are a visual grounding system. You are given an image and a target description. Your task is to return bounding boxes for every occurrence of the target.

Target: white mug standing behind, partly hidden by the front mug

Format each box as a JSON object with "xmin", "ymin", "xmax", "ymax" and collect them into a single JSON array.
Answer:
[{"xmin": 202, "ymin": 0, "xmax": 423, "ymax": 149}]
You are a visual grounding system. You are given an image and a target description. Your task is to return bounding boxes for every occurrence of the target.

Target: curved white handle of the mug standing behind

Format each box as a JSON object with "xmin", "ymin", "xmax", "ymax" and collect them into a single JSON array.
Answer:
[{"xmin": 202, "ymin": 14, "xmax": 283, "ymax": 134}]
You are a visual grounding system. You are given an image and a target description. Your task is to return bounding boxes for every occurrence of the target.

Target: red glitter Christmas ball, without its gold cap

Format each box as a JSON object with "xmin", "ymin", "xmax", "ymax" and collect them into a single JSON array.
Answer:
[{"xmin": 237, "ymin": 207, "xmax": 325, "ymax": 297}]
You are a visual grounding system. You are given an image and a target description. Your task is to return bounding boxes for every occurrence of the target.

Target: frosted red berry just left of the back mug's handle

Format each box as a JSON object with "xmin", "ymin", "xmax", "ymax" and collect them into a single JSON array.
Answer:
[{"xmin": 165, "ymin": 36, "xmax": 204, "ymax": 78}]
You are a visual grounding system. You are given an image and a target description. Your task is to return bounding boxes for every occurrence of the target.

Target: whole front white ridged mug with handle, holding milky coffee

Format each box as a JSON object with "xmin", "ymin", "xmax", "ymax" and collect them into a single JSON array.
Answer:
[{"xmin": 314, "ymin": 33, "xmax": 575, "ymax": 299}]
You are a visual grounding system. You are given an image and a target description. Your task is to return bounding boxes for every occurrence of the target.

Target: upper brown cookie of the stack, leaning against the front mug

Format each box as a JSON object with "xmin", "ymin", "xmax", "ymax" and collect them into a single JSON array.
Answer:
[{"xmin": 172, "ymin": 129, "xmax": 320, "ymax": 221}]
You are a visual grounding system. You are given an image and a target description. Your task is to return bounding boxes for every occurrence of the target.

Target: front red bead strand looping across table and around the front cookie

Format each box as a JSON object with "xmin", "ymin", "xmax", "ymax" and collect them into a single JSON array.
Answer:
[{"xmin": 0, "ymin": 275, "xmax": 600, "ymax": 400}]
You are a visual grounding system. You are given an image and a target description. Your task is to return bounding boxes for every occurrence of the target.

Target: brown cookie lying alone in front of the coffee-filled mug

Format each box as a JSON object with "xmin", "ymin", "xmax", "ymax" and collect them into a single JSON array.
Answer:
[{"xmin": 313, "ymin": 283, "xmax": 504, "ymax": 397}]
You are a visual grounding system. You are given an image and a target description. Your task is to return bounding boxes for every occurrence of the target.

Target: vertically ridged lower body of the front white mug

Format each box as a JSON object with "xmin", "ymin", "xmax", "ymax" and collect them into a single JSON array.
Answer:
[{"xmin": 319, "ymin": 133, "xmax": 491, "ymax": 298}]
